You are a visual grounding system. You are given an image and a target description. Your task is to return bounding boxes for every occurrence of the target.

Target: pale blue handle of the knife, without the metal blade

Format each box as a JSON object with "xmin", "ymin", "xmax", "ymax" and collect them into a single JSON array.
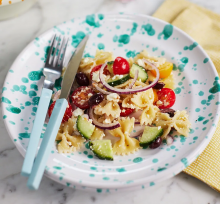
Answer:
[{"xmin": 27, "ymin": 99, "xmax": 68, "ymax": 190}]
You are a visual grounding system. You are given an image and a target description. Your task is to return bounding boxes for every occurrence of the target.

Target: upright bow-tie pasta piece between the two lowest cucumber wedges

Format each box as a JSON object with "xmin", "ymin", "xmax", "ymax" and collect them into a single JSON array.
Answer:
[{"xmin": 109, "ymin": 118, "xmax": 140, "ymax": 155}]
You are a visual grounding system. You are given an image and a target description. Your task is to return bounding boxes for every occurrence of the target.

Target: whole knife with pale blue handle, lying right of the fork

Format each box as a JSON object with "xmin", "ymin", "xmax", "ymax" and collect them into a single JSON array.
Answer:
[{"xmin": 27, "ymin": 36, "xmax": 89, "ymax": 190}]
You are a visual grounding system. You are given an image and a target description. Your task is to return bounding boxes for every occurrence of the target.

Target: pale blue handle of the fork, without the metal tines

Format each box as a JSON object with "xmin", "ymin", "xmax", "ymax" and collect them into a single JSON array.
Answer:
[{"xmin": 21, "ymin": 88, "xmax": 52, "ymax": 176}]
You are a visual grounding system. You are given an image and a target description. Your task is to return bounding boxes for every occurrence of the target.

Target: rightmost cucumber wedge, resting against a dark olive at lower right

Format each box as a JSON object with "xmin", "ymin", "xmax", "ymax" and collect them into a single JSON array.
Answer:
[{"xmin": 139, "ymin": 126, "xmax": 163, "ymax": 147}]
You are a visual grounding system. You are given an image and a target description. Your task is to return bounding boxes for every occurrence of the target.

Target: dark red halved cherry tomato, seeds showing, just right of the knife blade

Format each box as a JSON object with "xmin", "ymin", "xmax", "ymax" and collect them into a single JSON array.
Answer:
[{"xmin": 71, "ymin": 86, "xmax": 95, "ymax": 109}]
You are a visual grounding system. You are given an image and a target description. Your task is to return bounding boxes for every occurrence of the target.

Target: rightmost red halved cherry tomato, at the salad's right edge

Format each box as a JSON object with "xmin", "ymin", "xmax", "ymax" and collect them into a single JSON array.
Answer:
[{"xmin": 157, "ymin": 88, "xmax": 176, "ymax": 109}]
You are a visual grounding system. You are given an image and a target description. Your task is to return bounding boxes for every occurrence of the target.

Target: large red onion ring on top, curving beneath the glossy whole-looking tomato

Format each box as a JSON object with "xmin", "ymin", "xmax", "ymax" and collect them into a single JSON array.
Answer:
[{"xmin": 99, "ymin": 60, "xmax": 159, "ymax": 94}]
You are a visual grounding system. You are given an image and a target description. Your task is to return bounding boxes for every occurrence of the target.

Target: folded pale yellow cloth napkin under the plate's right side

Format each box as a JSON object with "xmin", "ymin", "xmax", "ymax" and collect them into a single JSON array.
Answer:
[{"xmin": 153, "ymin": 0, "xmax": 220, "ymax": 192}]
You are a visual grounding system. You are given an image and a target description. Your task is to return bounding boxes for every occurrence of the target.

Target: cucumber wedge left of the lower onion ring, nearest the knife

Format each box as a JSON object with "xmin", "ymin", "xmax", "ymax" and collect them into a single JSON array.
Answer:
[{"xmin": 76, "ymin": 115, "xmax": 95, "ymax": 139}]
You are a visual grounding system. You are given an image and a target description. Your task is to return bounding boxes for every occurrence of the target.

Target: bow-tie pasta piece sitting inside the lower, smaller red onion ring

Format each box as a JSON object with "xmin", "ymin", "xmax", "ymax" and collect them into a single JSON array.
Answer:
[{"xmin": 94, "ymin": 100, "xmax": 121, "ymax": 118}]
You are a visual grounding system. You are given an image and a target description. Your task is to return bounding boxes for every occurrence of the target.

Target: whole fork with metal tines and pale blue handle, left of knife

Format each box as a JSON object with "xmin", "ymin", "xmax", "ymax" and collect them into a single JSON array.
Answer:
[{"xmin": 21, "ymin": 35, "xmax": 68, "ymax": 176}]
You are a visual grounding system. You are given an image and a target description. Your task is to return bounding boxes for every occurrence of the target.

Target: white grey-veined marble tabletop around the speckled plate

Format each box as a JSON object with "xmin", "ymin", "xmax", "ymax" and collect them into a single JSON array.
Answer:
[{"xmin": 0, "ymin": 0, "xmax": 220, "ymax": 204}]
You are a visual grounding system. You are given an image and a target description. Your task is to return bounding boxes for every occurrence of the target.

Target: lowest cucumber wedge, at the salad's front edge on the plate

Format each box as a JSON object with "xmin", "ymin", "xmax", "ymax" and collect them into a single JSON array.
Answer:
[{"xmin": 89, "ymin": 140, "xmax": 113, "ymax": 161}]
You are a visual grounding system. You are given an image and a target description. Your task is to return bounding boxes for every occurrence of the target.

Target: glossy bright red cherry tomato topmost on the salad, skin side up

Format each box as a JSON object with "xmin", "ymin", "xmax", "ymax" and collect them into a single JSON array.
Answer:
[{"xmin": 113, "ymin": 57, "xmax": 130, "ymax": 75}]
